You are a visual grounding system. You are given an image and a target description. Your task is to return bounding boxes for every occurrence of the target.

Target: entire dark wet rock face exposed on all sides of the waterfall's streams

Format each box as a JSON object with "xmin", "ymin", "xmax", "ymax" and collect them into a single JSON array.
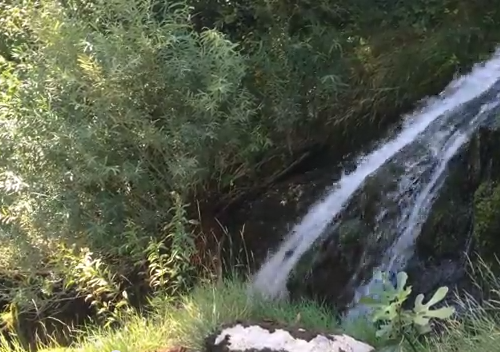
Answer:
[{"xmin": 216, "ymin": 119, "xmax": 500, "ymax": 312}]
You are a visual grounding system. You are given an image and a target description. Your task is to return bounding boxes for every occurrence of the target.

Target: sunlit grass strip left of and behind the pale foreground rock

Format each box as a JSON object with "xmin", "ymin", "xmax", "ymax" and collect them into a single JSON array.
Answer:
[{"xmin": 7, "ymin": 280, "xmax": 337, "ymax": 352}]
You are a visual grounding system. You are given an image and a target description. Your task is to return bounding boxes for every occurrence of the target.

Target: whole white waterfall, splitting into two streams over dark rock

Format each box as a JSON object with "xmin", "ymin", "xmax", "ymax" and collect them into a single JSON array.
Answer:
[{"xmin": 251, "ymin": 50, "xmax": 500, "ymax": 306}]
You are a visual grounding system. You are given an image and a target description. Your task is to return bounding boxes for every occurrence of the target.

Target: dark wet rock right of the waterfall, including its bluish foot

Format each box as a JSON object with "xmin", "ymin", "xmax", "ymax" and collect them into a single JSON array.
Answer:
[{"xmin": 407, "ymin": 128, "xmax": 500, "ymax": 293}]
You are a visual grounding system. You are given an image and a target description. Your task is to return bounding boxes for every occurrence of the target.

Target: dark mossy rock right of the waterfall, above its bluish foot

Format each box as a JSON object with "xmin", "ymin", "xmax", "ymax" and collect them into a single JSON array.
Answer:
[{"xmin": 417, "ymin": 128, "xmax": 500, "ymax": 262}]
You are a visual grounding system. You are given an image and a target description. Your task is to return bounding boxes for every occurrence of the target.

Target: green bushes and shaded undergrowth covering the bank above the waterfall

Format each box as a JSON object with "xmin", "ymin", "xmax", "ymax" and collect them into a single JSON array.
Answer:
[{"xmin": 0, "ymin": 0, "xmax": 500, "ymax": 344}]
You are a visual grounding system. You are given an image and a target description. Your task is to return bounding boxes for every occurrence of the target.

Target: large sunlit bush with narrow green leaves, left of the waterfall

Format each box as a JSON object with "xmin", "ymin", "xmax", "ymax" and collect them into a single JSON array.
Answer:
[{"xmin": 0, "ymin": 0, "xmax": 265, "ymax": 322}]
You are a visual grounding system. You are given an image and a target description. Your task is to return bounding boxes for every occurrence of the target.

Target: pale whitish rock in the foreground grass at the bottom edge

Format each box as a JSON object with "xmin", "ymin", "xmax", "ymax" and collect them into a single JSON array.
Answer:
[{"xmin": 205, "ymin": 322, "xmax": 374, "ymax": 352}]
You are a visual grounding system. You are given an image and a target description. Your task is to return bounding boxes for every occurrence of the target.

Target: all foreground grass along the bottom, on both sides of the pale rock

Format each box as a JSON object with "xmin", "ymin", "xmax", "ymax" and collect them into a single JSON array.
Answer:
[{"xmin": 4, "ymin": 280, "xmax": 500, "ymax": 352}]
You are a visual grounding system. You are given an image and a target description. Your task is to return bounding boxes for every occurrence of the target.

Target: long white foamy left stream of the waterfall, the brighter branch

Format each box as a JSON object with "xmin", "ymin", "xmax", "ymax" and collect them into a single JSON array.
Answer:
[{"xmin": 251, "ymin": 51, "xmax": 500, "ymax": 299}]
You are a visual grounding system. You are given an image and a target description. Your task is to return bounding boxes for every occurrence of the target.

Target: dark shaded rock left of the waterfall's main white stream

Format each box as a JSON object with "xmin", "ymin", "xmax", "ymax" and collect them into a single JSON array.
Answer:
[{"xmin": 220, "ymin": 153, "xmax": 352, "ymax": 274}]
